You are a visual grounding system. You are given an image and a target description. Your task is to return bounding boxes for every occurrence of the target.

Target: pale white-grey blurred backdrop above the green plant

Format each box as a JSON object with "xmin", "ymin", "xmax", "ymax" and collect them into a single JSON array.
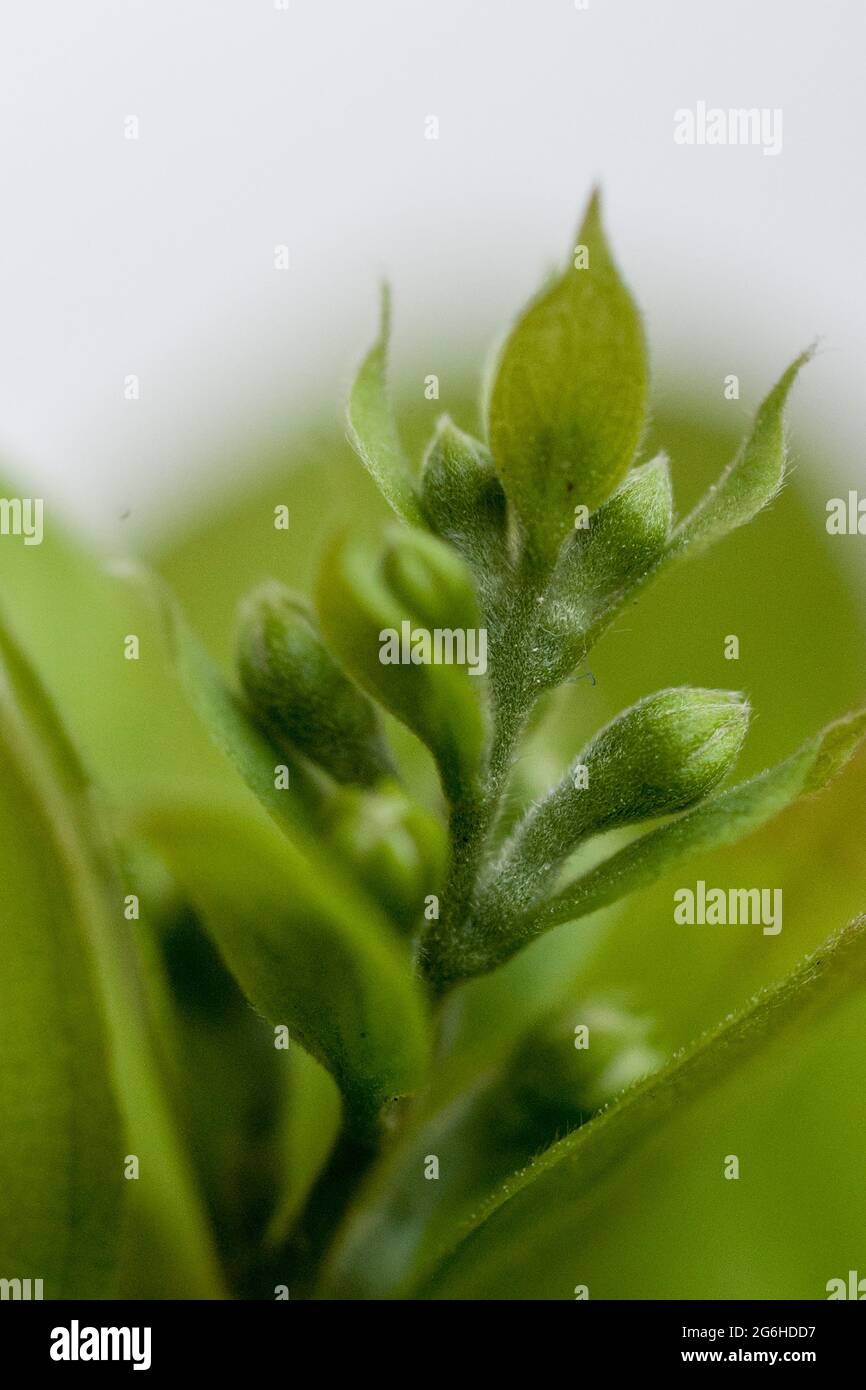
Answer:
[{"xmin": 0, "ymin": 0, "xmax": 866, "ymax": 537}]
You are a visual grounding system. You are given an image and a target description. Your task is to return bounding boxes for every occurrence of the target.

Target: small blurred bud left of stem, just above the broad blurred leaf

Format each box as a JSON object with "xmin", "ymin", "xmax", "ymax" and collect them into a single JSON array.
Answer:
[{"xmin": 327, "ymin": 783, "xmax": 446, "ymax": 930}]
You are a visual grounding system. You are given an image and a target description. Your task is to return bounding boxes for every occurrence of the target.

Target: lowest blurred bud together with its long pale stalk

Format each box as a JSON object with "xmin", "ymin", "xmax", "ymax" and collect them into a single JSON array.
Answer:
[{"xmin": 322, "ymin": 987, "xmax": 664, "ymax": 1298}]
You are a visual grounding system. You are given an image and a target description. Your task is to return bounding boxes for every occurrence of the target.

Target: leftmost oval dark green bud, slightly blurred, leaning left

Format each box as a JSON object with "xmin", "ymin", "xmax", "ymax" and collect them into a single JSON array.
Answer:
[{"xmin": 238, "ymin": 582, "xmax": 392, "ymax": 787}]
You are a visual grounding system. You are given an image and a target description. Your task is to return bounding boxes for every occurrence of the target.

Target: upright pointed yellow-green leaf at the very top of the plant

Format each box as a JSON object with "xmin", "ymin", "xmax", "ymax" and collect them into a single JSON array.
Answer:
[{"xmin": 488, "ymin": 193, "xmax": 648, "ymax": 566}]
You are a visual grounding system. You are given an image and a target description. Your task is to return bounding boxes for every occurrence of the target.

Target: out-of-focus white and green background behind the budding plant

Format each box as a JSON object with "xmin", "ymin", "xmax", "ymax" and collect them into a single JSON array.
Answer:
[{"xmin": 0, "ymin": 0, "xmax": 866, "ymax": 1298}]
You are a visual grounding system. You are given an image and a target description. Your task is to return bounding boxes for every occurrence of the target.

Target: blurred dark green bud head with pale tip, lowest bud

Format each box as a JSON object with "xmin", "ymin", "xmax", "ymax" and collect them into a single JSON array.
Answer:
[{"xmin": 509, "ymin": 1001, "xmax": 664, "ymax": 1131}]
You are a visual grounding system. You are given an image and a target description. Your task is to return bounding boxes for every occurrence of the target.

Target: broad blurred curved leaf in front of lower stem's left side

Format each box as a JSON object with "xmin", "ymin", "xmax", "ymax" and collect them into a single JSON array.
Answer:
[{"xmin": 140, "ymin": 805, "xmax": 430, "ymax": 1126}]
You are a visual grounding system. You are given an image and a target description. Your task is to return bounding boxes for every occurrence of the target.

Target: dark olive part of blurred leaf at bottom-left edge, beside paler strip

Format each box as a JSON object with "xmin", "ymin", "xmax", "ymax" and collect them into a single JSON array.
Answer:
[{"xmin": 0, "ymin": 617, "xmax": 124, "ymax": 1298}]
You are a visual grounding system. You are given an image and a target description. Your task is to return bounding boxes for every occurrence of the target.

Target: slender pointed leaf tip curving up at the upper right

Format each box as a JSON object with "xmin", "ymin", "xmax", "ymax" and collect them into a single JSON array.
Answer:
[{"xmin": 671, "ymin": 349, "xmax": 812, "ymax": 556}]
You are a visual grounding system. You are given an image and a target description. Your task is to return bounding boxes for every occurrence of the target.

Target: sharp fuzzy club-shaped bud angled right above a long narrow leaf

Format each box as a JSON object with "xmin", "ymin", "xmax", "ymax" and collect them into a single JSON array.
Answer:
[{"xmin": 480, "ymin": 687, "xmax": 749, "ymax": 922}]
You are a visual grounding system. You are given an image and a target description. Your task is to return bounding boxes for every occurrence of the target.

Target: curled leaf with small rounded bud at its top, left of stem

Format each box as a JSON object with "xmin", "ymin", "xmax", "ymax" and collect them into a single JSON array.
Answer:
[{"xmin": 317, "ymin": 531, "xmax": 487, "ymax": 799}]
